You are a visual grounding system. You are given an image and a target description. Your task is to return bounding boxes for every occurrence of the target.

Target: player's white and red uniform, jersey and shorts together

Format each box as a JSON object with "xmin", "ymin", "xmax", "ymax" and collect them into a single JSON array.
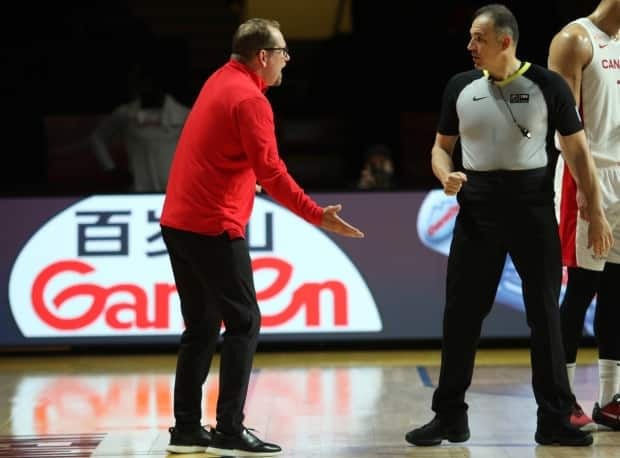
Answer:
[{"xmin": 555, "ymin": 18, "xmax": 620, "ymax": 271}]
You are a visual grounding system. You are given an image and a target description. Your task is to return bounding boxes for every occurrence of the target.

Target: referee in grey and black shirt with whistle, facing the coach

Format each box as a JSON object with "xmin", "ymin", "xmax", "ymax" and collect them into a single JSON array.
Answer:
[{"xmin": 406, "ymin": 4, "xmax": 612, "ymax": 446}]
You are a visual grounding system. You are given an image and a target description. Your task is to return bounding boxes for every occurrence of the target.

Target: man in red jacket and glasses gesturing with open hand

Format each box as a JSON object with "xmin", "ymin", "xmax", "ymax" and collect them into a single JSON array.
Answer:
[{"xmin": 161, "ymin": 19, "xmax": 363, "ymax": 456}]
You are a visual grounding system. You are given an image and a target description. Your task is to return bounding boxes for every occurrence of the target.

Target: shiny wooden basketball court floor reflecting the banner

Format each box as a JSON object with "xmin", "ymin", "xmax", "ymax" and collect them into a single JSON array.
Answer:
[{"xmin": 0, "ymin": 349, "xmax": 620, "ymax": 458}]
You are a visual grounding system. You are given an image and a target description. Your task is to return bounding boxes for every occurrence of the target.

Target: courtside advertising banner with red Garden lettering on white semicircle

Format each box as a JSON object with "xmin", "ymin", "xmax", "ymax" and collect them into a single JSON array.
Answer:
[{"xmin": 0, "ymin": 190, "xmax": 591, "ymax": 346}]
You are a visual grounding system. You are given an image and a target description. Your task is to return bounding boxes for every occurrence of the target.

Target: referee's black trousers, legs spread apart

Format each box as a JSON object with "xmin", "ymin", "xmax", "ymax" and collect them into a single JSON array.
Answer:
[{"xmin": 432, "ymin": 176, "xmax": 573, "ymax": 420}]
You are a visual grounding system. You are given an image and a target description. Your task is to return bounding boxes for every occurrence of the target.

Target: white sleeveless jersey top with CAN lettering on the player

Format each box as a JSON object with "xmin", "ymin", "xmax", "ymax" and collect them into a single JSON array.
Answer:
[{"xmin": 574, "ymin": 18, "xmax": 620, "ymax": 168}]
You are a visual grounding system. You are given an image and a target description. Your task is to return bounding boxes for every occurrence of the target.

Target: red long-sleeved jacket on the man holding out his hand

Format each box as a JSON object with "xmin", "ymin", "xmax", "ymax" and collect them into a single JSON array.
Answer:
[{"xmin": 160, "ymin": 60, "xmax": 323, "ymax": 239}]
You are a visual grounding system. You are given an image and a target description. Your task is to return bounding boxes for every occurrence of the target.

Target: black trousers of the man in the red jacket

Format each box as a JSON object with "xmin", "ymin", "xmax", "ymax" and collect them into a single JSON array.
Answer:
[{"xmin": 162, "ymin": 226, "xmax": 260, "ymax": 434}]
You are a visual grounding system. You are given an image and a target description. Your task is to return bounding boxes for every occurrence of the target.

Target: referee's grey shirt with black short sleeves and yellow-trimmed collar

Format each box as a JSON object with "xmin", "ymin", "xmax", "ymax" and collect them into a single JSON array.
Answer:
[{"xmin": 437, "ymin": 62, "xmax": 583, "ymax": 171}]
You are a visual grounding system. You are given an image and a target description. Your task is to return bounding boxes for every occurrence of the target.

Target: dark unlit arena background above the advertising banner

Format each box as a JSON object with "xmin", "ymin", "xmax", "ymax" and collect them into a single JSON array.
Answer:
[{"xmin": 0, "ymin": 0, "xmax": 598, "ymax": 194}]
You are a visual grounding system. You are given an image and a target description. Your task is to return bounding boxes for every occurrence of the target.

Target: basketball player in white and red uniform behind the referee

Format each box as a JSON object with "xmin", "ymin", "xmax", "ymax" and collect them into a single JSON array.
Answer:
[{"xmin": 549, "ymin": 0, "xmax": 620, "ymax": 430}]
